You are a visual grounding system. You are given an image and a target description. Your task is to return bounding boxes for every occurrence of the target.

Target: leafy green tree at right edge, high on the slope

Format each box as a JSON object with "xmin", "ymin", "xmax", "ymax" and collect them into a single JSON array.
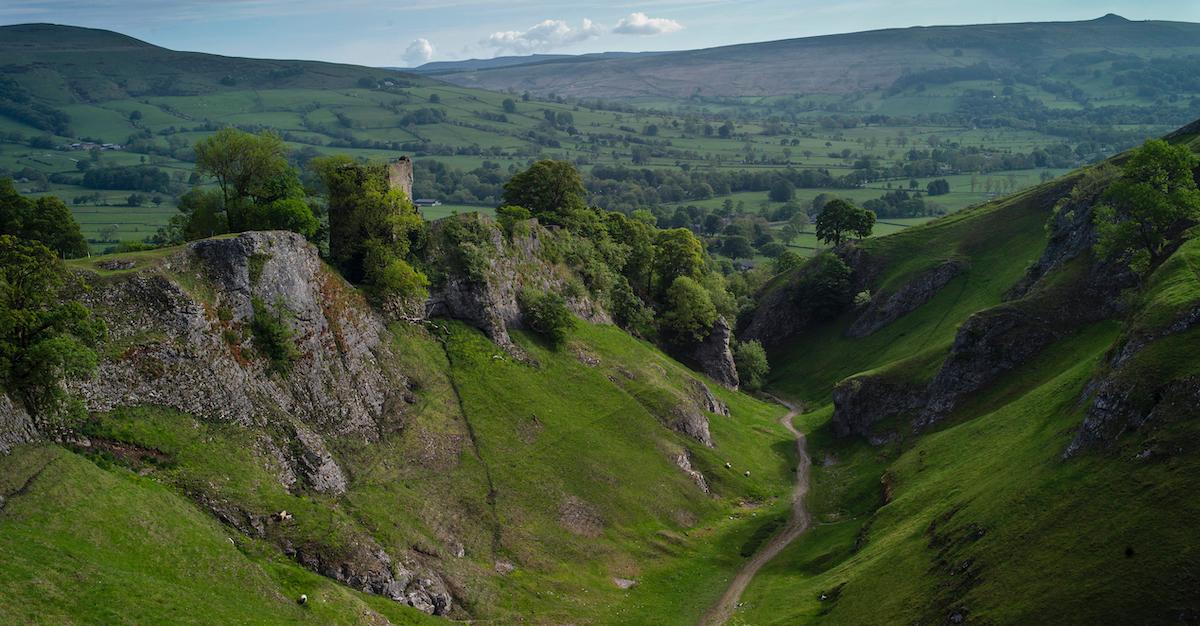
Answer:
[{"xmin": 1096, "ymin": 139, "xmax": 1200, "ymax": 273}]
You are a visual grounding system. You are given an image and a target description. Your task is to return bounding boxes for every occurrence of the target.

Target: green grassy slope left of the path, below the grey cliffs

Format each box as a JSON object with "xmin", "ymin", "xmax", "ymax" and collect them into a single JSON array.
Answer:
[{"xmin": 0, "ymin": 242, "xmax": 806, "ymax": 624}]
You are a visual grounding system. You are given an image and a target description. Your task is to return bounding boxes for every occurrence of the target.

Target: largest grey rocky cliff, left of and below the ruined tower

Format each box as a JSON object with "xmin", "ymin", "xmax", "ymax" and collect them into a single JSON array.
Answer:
[{"xmin": 74, "ymin": 233, "xmax": 406, "ymax": 439}]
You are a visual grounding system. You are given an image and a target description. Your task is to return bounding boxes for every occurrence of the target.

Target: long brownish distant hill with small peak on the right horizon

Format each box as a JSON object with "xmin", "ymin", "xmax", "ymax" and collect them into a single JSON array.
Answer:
[{"xmin": 443, "ymin": 14, "xmax": 1200, "ymax": 98}]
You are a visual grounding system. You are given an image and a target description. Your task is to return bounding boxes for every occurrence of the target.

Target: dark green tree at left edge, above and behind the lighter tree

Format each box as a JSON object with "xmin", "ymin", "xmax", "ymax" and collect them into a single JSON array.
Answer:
[{"xmin": 0, "ymin": 179, "xmax": 88, "ymax": 258}]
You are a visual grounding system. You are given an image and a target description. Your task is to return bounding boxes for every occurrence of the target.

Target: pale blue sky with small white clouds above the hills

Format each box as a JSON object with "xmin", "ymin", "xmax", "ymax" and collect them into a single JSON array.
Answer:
[{"xmin": 0, "ymin": 0, "xmax": 1200, "ymax": 67}]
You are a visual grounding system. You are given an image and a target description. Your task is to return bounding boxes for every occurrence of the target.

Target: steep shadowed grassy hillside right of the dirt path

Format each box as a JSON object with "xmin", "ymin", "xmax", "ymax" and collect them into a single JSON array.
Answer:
[{"xmin": 736, "ymin": 125, "xmax": 1200, "ymax": 625}]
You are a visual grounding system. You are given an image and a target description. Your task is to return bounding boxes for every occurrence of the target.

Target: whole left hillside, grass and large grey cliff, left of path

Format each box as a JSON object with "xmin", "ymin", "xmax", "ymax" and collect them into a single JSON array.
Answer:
[{"xmin": 0, "ymin": 234, "xmax": 793, "ymax": 624}]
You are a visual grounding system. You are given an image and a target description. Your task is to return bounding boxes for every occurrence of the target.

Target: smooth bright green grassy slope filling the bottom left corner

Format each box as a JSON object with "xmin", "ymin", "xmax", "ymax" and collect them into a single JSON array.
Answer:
[{"xmin": 0, "ymin": 446, "xmax": 436, "ymax": 624}]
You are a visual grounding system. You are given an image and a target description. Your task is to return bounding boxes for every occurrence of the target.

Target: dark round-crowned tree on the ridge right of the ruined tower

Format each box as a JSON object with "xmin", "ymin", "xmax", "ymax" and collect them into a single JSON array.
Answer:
[{"xmin": 500, "ymin": 161, "xmax": 587, "ymax": 225}]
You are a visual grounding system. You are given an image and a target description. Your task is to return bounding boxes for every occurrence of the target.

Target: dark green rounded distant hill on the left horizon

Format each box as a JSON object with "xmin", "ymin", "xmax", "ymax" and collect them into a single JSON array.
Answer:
[{"xmin": 0, "ymin": 24, "xmax": 429, "ymax": 104}]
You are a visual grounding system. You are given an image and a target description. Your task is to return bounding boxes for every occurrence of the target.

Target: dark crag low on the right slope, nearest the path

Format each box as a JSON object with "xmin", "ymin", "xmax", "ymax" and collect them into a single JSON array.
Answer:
[{"xmin": 830, "ymin": 374, "xmax": 929, "ymax": 441}]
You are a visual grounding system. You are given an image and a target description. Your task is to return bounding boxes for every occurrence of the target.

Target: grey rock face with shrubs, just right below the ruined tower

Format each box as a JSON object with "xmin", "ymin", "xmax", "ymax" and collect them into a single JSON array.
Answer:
[{"xmin": 425, "ymin": 213, "xmax": 612, "ymax": 356}]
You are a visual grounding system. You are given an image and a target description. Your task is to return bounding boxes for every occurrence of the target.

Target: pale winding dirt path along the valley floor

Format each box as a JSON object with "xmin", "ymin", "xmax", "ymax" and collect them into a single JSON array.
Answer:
[{"xmin": 700, "ymin": 398, "xmax": 812, "ymax": 626}]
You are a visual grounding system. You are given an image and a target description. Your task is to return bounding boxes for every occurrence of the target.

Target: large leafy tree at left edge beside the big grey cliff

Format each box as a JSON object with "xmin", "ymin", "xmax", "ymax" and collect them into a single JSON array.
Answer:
[{"xmin": 0, "ymin": 235, "xmax": 104, "ymax": 414}]
